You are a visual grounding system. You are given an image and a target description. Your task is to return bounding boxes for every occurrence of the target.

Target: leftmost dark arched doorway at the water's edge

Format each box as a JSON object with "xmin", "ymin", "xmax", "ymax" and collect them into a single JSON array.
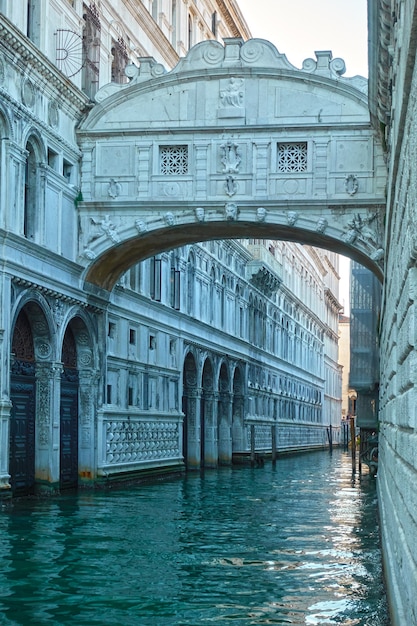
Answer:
[{"xmin": 9, "ymin": 311, "xmax": 36, "ymax": 496}]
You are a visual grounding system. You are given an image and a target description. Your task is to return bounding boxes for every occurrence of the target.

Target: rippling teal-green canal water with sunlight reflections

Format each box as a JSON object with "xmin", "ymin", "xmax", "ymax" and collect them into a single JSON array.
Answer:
[{"xmin": 0, "ymin": 451, "xmax": 389, "ymax": 626}]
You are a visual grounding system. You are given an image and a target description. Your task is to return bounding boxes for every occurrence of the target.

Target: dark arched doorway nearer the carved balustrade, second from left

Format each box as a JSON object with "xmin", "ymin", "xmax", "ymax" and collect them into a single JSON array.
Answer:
[{"xmin": 59, "ymin": 326, "xmax": 79, "ymax": 490}]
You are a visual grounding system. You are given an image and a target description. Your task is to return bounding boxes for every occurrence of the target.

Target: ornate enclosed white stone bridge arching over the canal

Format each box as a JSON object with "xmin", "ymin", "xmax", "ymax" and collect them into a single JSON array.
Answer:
[{"xmin": 78, "ymin": 39, "xmax": 386, "ymax": 290}]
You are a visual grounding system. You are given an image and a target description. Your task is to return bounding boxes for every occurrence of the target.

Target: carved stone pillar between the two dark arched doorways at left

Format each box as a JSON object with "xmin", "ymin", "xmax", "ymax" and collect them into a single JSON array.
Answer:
[{"xmin": 35, "ymin": 362, "xmax": 63, "ymax": 492}]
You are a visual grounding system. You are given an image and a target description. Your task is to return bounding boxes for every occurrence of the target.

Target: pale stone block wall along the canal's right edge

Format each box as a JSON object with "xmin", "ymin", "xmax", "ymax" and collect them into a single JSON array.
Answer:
[{"xmin": 377, "ymin": 17, "xmax": 417, "ymax": 626}]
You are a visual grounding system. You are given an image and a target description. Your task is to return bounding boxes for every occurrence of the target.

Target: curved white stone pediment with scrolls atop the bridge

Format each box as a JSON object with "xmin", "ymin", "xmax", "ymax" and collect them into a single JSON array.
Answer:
[{"xmin": 88, "ymin": 39, "xmax": 368, "ymax": 131}]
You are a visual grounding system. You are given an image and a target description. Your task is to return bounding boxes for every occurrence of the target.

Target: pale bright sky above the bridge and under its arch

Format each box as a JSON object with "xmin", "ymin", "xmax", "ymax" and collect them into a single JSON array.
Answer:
[{"xmin": 237, "ymin": 0, "xmax": 368, "ymax": 315}]
